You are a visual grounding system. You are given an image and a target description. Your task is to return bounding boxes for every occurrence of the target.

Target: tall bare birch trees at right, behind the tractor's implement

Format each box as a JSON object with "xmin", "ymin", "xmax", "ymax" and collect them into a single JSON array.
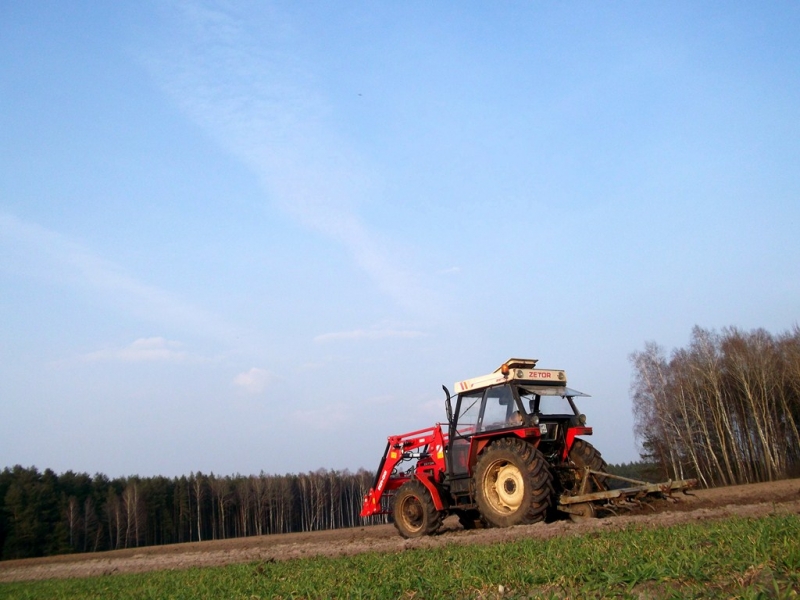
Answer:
[{"xmin": 631, "ymin": 326, "xmax": 800, "ymax": 487}]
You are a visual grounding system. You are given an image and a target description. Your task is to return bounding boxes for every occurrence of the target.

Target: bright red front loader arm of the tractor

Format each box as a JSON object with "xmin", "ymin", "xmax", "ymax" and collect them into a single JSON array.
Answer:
[{"xmin": 361, "ymin": 423, "xmax": 447, "ymax": 517}]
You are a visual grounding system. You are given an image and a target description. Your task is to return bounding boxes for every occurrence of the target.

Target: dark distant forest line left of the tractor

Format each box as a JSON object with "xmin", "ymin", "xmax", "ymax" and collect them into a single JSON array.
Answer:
[{"xmin": 0, "ymin": 466, "xmax": 385, "ymax": 559}]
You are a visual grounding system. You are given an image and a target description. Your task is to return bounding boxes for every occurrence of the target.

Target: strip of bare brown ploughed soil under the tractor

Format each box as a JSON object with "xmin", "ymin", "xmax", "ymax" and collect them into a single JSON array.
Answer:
[{"xmin": 0, "ymin": 479, "xmax": 800, "ymax": 582}]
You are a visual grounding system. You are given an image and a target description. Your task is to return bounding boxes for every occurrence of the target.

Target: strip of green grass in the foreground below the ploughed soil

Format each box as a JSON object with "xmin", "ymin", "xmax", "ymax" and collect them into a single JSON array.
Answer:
[{"xmin": 0, "ymin": 515, "xmax": 800, "ymax": 600}]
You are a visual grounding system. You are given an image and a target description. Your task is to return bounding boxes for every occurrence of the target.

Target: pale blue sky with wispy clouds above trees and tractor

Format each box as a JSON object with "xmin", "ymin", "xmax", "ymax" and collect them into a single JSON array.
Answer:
[{"xmin": 0, "ymin": 0, "xmax": 800, "ymax": 477}]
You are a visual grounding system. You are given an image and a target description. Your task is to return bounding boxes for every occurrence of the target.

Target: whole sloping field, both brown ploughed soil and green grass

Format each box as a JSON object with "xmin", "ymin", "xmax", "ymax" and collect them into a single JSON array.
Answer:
[{"xmin": 0, "ymin": 480, "xmax": 800, "ymax": 598}]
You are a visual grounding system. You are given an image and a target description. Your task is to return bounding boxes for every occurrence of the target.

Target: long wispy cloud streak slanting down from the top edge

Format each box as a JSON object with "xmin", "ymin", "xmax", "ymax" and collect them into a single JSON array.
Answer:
[{"xmin": 146, "ymin": 2, "xmax": 436, "ymax": 311}]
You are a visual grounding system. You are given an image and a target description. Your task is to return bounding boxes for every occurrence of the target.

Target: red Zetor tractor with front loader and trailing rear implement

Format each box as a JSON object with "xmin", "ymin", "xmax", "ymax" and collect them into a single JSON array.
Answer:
[{"xmin": 361, "ymin": 358, "xmax": 694, "ymax": 537}]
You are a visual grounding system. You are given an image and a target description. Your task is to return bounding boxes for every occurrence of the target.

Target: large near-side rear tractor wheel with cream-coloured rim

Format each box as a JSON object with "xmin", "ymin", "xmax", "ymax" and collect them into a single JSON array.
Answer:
[{"xmin": 475, "ymin": 438, "xmax": 553, "ymax": 527}]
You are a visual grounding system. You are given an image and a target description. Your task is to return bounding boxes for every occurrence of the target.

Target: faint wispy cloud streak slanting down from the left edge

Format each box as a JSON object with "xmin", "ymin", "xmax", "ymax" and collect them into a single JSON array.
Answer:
[{"xmin": 0, "ymin": 213, "xmax": 231, "ymax": 338}]
